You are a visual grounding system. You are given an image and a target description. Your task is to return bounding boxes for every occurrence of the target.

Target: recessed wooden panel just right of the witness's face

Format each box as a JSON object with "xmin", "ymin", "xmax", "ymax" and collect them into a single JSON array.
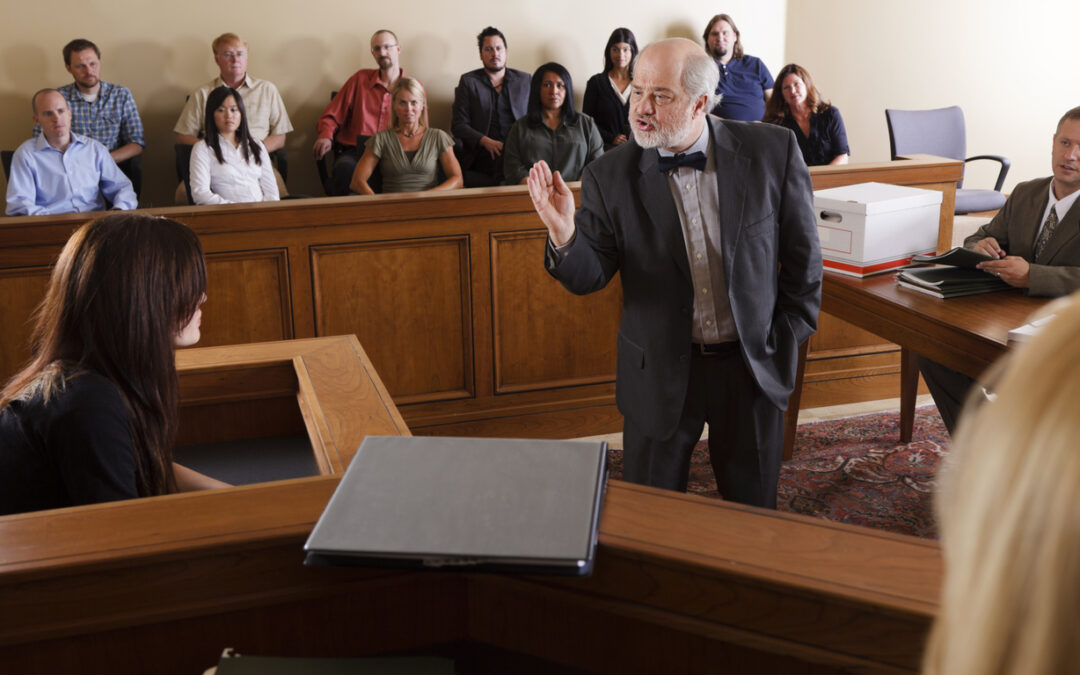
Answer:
[{"xmin": 199, "ymin": 248, "xmax": 294, "ymax": 347}]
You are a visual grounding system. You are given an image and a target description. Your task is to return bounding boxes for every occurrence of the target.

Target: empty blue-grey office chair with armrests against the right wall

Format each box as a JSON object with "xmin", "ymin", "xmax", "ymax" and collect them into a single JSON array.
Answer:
[{"xmin": 885, "ymin": 106, "xmax": 1012, "ymax": 214}]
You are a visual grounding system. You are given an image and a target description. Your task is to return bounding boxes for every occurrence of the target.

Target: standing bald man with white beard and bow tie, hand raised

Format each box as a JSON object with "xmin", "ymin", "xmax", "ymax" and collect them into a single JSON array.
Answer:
[{"xmin": 528, "ymin": 39, "xmax": 822, "ymax": 508}]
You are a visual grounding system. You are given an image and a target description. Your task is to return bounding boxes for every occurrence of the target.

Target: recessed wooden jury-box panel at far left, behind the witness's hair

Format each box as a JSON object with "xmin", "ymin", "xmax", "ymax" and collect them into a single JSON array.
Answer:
[{"xmin": 0, "ymin": 267, "xmax": 52, "ymax": 380}]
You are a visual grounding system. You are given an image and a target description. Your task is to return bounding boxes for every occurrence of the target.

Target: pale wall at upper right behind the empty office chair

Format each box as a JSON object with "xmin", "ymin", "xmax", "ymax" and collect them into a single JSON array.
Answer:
[{"xmin": 786, "ymin": 0, "xmax": 1080, "ymax": 190}]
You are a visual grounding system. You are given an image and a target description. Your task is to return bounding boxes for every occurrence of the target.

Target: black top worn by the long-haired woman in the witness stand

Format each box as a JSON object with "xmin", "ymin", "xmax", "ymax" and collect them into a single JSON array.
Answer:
[{"xmin": 0, "ymin": 373, "xmax": 138, "ymax": 514}]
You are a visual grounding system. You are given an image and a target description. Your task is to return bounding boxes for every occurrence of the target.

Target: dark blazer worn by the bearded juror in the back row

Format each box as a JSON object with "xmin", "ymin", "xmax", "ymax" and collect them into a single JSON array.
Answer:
[{"xmin": 450, "ymin": 68, "xmax": 532, "ymax": 170}]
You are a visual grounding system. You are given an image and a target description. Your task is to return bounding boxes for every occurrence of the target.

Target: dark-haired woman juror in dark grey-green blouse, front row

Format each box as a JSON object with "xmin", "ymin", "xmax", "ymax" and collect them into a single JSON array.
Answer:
[{"xmin": 502, "ymin": 63, "xmax": 604, "ymax": 185}]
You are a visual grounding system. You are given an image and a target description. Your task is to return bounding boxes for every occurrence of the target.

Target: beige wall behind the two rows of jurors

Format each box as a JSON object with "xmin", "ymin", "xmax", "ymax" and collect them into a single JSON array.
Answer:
[{"xmin": 0, "ymin": 0, "xmax": 786, "ymax": 205}]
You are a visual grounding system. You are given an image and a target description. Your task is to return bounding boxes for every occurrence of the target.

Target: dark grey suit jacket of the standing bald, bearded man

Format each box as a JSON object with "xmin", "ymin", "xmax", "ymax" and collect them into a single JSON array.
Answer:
[{"xmin": 548, "ymin": 117, "xmax": 822, "ymax": 440}]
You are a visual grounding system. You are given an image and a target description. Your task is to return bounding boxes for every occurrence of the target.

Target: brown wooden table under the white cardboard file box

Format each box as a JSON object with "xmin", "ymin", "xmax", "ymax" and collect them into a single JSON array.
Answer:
[{"xmin": 821, "ymin": 272, "xmax": 1048, "ymax": 443}]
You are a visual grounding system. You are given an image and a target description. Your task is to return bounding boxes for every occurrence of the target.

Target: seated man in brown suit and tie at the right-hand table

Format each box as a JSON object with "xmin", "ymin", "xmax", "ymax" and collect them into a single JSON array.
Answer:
[{"xmin": 918, "ymin": 107, "xmax": 1080, "ymax": 434}]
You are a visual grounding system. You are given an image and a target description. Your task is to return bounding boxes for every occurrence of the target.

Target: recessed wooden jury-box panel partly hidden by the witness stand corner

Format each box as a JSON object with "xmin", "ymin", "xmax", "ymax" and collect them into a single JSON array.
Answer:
[{"xmin": 311, "ymin": 237, "xmax": 473, "ymax": 404}]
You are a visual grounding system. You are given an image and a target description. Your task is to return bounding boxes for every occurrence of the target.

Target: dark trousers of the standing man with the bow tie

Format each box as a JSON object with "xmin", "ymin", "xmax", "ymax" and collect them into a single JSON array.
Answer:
[{"xmin": 622, "ymin": 345, "xmax": 784, "ymax": 509}]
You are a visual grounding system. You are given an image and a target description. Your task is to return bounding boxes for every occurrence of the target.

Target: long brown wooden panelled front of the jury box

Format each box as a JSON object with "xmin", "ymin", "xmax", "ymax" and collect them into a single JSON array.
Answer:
[{"xmin": 0, "ymin": 157, "xmax": 961, "ymax": 437}]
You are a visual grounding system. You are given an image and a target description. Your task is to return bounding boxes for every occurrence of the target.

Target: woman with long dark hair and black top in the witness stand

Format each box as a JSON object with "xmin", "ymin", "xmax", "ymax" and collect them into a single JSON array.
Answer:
[{"xmin": 0, "ymin": 214, "xmax": 226, "ymax": 514}]
